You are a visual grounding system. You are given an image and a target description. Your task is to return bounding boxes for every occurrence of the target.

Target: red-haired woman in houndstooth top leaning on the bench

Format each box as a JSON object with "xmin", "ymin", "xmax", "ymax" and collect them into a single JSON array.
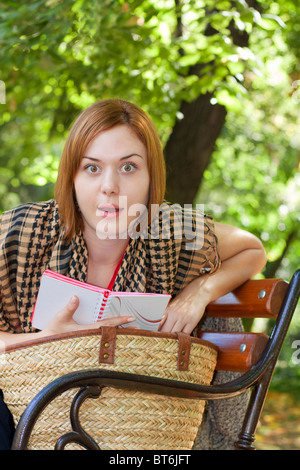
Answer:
[{"xmin": 0, "ymin": 100, "xmax": 266, "ymax": 448}]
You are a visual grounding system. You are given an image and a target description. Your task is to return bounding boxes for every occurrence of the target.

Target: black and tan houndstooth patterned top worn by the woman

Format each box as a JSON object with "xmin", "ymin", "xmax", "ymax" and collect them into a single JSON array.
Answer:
[{"xmin": 0, "ymin": 199, "xmax": 220, "ymax": 333}]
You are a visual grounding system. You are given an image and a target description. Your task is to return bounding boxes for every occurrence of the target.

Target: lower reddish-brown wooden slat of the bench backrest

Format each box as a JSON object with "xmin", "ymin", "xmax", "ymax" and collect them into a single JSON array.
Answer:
[{"xmin": 197, "ymin": 330, "xmax": 268, "ymax": 372}]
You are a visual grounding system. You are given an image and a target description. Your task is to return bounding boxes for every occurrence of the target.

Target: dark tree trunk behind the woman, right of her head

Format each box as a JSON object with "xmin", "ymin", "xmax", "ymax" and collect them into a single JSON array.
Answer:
[{"xmin": 164, "ymin": 94, "xmax": 226, "ymax": 204}]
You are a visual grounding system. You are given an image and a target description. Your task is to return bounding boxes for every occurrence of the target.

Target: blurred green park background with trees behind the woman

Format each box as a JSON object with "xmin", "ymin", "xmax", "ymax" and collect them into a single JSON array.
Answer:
[{"xmin": 0, "ymin": 0, "xmax": 300, "ymax": 449}]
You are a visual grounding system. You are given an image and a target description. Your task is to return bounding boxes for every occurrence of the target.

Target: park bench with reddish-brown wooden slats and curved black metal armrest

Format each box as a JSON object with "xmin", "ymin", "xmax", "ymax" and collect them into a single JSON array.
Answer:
[{"xmin": 12, "ymin": 270, "xmax": 300, "ymax": 450}]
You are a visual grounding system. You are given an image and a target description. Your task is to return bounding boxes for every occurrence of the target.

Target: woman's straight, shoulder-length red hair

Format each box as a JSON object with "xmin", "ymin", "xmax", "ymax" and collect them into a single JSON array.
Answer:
[{"xmin": 55, "ymin": 99, "xmax": 166, "ymax": 242}]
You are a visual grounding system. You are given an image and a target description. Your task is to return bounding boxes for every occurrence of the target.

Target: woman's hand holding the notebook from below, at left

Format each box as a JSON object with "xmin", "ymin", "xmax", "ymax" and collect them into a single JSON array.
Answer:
[{"xmin": 42, "ymin": 295, "xmax": 135, "ymax": 336}]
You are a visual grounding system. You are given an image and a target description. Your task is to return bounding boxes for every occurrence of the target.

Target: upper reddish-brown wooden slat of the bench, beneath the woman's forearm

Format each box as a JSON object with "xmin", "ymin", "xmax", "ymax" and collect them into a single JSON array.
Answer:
[{"xmin": 205, "ymin": 279, "xmax": 288, "ymax": 318}]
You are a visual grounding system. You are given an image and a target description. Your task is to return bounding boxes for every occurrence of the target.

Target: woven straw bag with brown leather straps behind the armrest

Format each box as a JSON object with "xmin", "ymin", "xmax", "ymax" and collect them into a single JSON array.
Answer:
[{"xmin": 0, "ymin": 327, "xmax": 217, "ymax": 450}]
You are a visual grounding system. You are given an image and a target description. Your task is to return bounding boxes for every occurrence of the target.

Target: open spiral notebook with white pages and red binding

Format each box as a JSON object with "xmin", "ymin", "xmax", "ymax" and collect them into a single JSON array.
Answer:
[{"xmin": 31, "ymin": 269, "xmax": 171, "ymax": 331}]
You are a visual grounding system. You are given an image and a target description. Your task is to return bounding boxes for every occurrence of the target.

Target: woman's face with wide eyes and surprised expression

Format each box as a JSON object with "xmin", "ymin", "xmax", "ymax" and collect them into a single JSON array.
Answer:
[{"xmin": 74, "ymin": 125, "xmax": 150, "ymax": 239}]
